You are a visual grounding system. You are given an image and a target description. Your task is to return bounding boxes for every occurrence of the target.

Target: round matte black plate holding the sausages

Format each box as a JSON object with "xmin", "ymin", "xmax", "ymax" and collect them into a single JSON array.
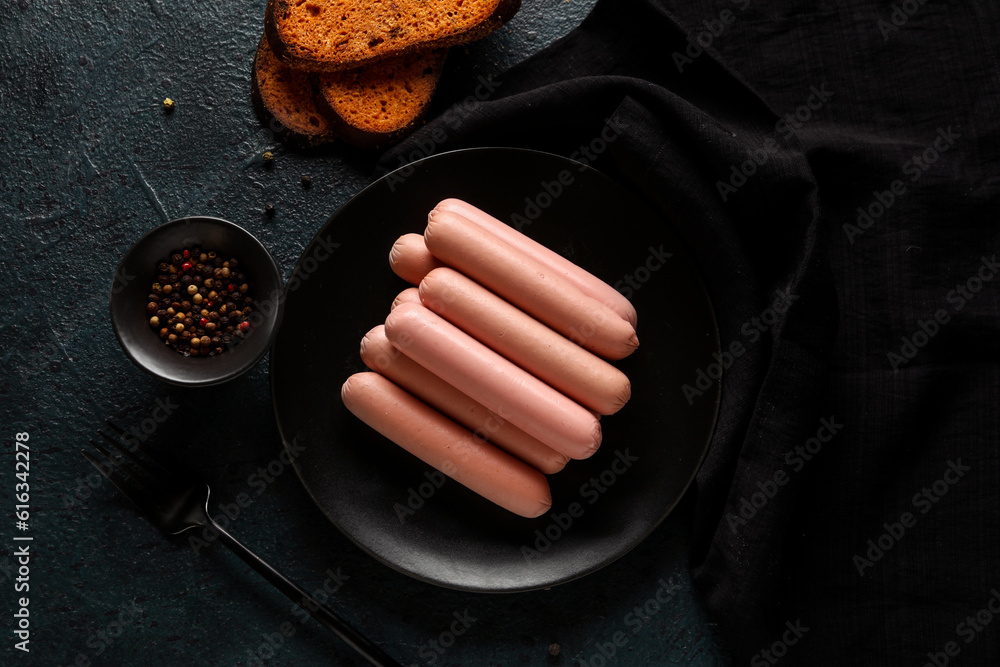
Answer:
[{"xmin": 271, "ymin": 148, "xmax": 719, "ymax": 592}]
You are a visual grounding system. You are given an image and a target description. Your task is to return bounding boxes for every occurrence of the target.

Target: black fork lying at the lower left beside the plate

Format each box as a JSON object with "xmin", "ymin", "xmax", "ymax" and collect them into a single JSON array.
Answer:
[{"xmin": 83, "ymin": 420, "xmax": 401, "ymax": 667}]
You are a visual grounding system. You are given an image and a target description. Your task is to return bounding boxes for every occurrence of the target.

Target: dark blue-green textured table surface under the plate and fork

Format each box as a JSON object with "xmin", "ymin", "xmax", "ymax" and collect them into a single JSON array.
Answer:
[{"xmin": 0, "ymin": 0, "xmax": 724, "ymax": 666}]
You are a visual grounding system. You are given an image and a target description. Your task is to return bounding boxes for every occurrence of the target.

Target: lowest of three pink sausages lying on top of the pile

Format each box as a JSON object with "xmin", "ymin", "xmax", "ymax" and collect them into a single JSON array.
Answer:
[{"xmin": 385, "ymin": 303, "xmax": 601, "ymax": 459}]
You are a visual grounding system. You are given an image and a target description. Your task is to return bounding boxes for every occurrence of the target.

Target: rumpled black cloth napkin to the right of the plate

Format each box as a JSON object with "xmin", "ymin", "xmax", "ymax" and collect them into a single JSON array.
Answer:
[{"xmin": 380, "ymin": 0, "xmax": 1000, "ymax": 667}]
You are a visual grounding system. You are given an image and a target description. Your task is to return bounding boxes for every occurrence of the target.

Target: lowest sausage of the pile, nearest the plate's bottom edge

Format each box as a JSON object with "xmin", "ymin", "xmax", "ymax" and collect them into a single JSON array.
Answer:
[{"xmin": 340, "ymin": 373, "xmax": 552, "ymax": 518}]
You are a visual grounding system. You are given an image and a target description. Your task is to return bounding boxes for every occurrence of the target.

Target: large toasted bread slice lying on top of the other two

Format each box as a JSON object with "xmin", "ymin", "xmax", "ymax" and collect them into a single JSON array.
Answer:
[{"xmin": 264, "ymin": 0, "xmax": 521, "ymax": 72}]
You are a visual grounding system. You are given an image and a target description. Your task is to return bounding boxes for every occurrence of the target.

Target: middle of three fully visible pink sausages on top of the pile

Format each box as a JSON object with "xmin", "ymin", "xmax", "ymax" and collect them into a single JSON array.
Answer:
[{"xmin": 419, "ymin": 267, "xmax": 632, "ymax": 415}]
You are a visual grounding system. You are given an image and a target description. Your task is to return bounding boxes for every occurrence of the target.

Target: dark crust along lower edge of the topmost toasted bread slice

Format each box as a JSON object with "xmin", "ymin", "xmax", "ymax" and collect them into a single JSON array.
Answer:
[{"xmin": 264, "ymin": 0, "xmax": 521, "ymax": 72}]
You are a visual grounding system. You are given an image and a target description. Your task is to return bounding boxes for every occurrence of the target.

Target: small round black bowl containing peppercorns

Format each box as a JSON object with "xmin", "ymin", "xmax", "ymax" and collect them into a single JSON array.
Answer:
[{"xmin": 111, "ymin": 216, "xmax": 284, "ymax": 387}]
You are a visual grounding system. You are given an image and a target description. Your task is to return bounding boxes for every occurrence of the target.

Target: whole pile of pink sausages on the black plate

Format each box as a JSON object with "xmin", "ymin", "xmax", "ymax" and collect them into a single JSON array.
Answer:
[{"xmin": 341, "ymin": 199, "xmax": 639, "ymax": 518}]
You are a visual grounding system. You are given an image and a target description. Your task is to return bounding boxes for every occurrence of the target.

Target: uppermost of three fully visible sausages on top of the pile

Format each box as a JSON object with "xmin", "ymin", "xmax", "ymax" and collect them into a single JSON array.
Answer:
[{"xmin": 424, "ymin": 210, "xmax": 639, "ymax": 359}]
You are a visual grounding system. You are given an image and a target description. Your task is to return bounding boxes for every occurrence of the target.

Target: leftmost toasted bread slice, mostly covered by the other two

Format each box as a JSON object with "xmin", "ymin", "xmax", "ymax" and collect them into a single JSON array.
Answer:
[{"xmin": 251, "ymin": 37, "xmax": 334, "ymax": 146}]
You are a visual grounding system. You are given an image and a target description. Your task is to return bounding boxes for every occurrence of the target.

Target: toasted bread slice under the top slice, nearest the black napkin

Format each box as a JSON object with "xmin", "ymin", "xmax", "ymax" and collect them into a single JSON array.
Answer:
[{"xmin": 316, "ymin": 49, "xmax": 448, "ymax": 147}]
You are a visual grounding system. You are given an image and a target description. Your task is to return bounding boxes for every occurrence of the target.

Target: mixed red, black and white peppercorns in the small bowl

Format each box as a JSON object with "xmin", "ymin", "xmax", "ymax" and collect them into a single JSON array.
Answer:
[{"xmin": 146, "ymin": 247, "xmax": 254, "ymax": 357}]
